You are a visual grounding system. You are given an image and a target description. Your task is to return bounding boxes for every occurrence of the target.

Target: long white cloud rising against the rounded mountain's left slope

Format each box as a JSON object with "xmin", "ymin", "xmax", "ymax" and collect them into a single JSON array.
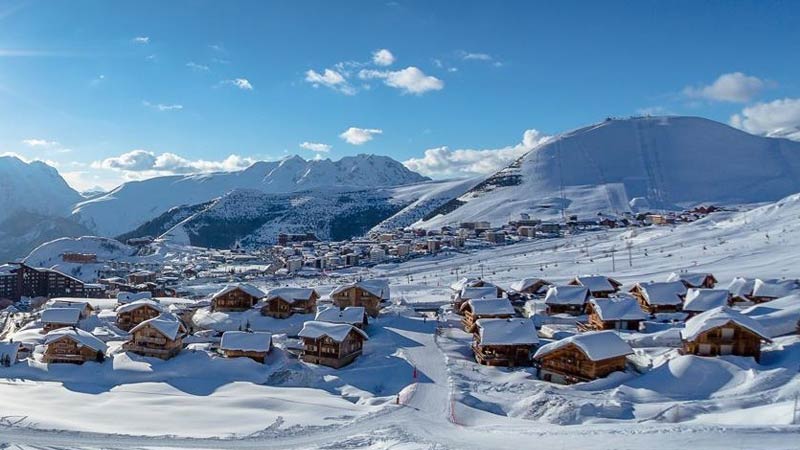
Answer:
[{"xmin": 403, "ymin": 129, "xmax": 552, "ymax": 177}]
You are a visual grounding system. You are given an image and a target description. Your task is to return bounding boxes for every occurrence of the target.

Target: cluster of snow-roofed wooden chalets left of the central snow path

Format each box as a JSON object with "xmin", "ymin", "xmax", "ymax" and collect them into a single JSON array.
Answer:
[{"xmin": 0, "ymin": 280, "xmax": 390, "ymax": 368}]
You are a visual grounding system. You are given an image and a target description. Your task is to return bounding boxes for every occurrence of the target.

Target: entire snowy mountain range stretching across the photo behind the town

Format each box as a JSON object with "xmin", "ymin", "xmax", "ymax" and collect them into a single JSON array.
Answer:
[{"xmin": 0, "ymin": 117, "xmax": 800, "ymax": 259}]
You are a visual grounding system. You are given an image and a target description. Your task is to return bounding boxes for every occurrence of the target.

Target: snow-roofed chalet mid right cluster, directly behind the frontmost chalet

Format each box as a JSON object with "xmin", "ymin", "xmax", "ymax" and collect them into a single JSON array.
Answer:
[{"xmin": 578, "ymin": 296, "xmax": 647, "ymax": 331}]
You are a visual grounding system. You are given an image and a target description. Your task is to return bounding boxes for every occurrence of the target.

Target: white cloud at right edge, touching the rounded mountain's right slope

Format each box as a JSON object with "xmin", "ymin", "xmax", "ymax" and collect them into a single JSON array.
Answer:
[{"xmin": 730, "ymin": 98, "xmax": 800, "ymax": 141}]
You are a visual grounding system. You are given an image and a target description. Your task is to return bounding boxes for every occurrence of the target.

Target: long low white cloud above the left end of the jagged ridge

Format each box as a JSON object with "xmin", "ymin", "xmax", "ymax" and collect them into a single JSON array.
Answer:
[{"xmin": 91, "ymin": 150, "xmax": 255, "ymax": 177}]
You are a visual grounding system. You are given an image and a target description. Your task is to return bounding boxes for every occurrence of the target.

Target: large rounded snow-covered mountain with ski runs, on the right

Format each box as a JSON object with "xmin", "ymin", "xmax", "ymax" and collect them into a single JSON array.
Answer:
[{"xmin": 420, "ymin": 117, "xmax": 800, "ymax": 227}]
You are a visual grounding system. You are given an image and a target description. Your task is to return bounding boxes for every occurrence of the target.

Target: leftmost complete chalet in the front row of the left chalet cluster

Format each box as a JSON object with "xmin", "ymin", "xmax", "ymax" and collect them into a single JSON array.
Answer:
[{"xmin": 42, "ymin": 327, "xmax": 106, "ymax": 364}]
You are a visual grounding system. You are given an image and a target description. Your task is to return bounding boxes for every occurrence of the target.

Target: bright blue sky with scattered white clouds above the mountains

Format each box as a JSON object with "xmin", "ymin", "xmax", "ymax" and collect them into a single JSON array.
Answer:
[{"xmin": 0, "ymin": 0, "xmax": 800, "ymax": 189}]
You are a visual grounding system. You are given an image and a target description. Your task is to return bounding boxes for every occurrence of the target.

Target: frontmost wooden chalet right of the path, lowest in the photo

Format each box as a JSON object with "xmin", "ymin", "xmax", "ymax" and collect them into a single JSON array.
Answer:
[{"xmin": 533, "ymin": 331, "xmax": 633, "ymax": 384}]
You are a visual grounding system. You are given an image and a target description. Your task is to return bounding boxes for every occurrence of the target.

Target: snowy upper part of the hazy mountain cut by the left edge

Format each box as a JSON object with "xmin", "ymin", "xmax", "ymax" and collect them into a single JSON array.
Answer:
[{"xmin": 0, "ymin": 156, "xmax": 82, "ymax": 222}]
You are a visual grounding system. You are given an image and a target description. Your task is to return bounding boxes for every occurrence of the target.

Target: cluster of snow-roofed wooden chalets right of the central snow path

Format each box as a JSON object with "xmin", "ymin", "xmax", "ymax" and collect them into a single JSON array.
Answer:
[{"xmin": 451, "ymin": 273, "xmax": 800, "ymax": 383}]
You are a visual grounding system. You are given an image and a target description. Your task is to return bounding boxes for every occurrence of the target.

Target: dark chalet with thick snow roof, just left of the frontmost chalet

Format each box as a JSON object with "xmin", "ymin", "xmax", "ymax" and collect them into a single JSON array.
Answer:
[{"xmin": 472, "ymin": 319, "xmax": 539, "ymax": 367}]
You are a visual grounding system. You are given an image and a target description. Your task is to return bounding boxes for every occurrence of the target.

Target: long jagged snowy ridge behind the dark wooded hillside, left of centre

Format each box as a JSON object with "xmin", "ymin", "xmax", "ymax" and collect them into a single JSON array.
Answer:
[{"xmin": 74, "ymin": 155, "xmax": 427, "ymax": 236}]
